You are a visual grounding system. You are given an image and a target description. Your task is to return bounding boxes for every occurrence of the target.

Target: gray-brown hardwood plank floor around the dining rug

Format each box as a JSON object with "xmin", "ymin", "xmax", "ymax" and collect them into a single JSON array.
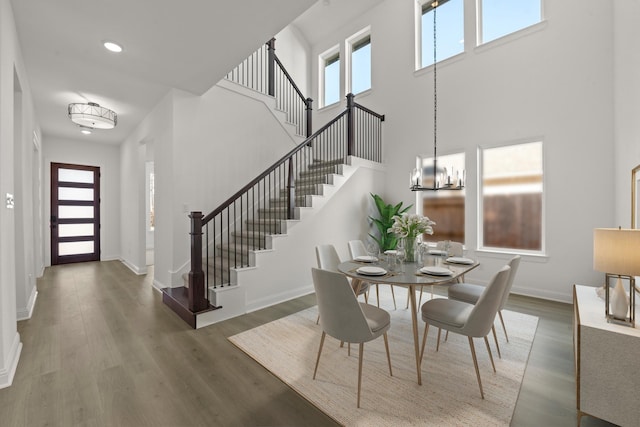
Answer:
[{"xmin": 0, "ymin": 261, "xmax": 609, "ymax": 427}]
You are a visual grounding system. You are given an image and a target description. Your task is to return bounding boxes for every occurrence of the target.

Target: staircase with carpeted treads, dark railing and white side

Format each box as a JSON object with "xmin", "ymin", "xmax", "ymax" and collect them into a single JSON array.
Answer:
[{"xmin": 163, "ymin": 41, "xmax": 384, "ymax": 328}]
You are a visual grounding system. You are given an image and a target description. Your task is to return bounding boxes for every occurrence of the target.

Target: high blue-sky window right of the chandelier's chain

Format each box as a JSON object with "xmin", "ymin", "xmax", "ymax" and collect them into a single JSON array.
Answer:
[{"xmin": 478, "ymin": 0, "xmax": 542, "ymax": 44}]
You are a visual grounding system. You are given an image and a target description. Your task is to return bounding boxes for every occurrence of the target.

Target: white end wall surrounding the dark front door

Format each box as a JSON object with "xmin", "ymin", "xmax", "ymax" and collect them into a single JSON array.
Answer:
[{"xmin": 42, "ymin": 137, "xmax": 120, "ymax": 266}]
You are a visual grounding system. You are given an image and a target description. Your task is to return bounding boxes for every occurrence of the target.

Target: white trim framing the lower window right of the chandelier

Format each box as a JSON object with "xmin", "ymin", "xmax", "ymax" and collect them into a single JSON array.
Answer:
[{"xmin": 476, "ymin": 137, "xmax": 547, "ymax": 257}]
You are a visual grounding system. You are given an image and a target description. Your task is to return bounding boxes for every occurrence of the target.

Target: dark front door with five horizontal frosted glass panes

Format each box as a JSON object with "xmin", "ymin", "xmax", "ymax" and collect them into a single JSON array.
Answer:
[{"xmin": 51, "ymin": 163, "xmax": 100, "ymax": 265}]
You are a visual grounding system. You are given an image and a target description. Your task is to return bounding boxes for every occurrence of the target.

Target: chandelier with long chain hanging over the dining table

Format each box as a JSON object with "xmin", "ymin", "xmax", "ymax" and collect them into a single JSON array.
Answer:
[{"xmin": 410, "ymin": 0, "xmax": 466, "ymax": 191}]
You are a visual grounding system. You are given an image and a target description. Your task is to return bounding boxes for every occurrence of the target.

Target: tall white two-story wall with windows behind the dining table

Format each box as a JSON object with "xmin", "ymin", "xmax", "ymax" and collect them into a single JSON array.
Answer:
[{"xmin": 312, "ymin": 0, "xmax": 616, "ymax": 302}]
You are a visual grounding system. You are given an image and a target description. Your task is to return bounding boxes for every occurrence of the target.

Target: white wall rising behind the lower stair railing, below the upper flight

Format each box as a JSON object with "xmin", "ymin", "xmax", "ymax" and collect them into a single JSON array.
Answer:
[{"xmin": 121, "ymin": 82, "xmax": 304, "ymax": 287}]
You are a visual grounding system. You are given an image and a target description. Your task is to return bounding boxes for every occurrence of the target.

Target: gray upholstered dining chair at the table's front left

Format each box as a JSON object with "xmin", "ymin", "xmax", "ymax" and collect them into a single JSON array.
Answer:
[{"xmin": 311, "ymin": 268, "xmax": 393, "ymax": 408}]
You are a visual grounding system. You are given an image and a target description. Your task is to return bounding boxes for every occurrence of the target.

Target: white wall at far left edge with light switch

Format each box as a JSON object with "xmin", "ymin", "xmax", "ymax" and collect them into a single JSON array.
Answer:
[{"xmin": 0, "ymin": 0, "xmax": 39, "ymax": 388}]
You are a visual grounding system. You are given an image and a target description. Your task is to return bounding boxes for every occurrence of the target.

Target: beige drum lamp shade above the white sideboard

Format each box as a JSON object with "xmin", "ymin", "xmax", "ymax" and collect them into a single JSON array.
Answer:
[{"xmin": 593, "ymin": 228, "xmax": 640, "ymax": 276}]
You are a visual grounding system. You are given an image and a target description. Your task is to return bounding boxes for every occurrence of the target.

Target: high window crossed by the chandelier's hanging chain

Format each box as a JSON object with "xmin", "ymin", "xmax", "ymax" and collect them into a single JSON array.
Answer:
[{"xmin": 419, "ymin": 0, "xmax": 464, "ymax": 68}]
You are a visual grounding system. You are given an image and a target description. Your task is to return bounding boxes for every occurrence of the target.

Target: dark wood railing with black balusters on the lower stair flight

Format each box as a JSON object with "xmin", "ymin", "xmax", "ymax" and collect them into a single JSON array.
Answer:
[{"xmin": 169, "ymin": 94, "xmax": 384, "ymax": 326}]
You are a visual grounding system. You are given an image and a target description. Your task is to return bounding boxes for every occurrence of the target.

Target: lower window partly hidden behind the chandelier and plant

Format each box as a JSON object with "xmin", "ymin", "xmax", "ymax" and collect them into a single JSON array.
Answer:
[{"xmin": 417, "ymin": 153, "xmax": 465, "ymax": 243}]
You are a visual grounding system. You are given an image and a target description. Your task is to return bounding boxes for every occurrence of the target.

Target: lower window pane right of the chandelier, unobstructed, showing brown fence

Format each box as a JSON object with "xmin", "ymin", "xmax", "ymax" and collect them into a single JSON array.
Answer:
[{"xmin": 479, "ymin": 142, "xmax": 543, "ymax": 252}]
